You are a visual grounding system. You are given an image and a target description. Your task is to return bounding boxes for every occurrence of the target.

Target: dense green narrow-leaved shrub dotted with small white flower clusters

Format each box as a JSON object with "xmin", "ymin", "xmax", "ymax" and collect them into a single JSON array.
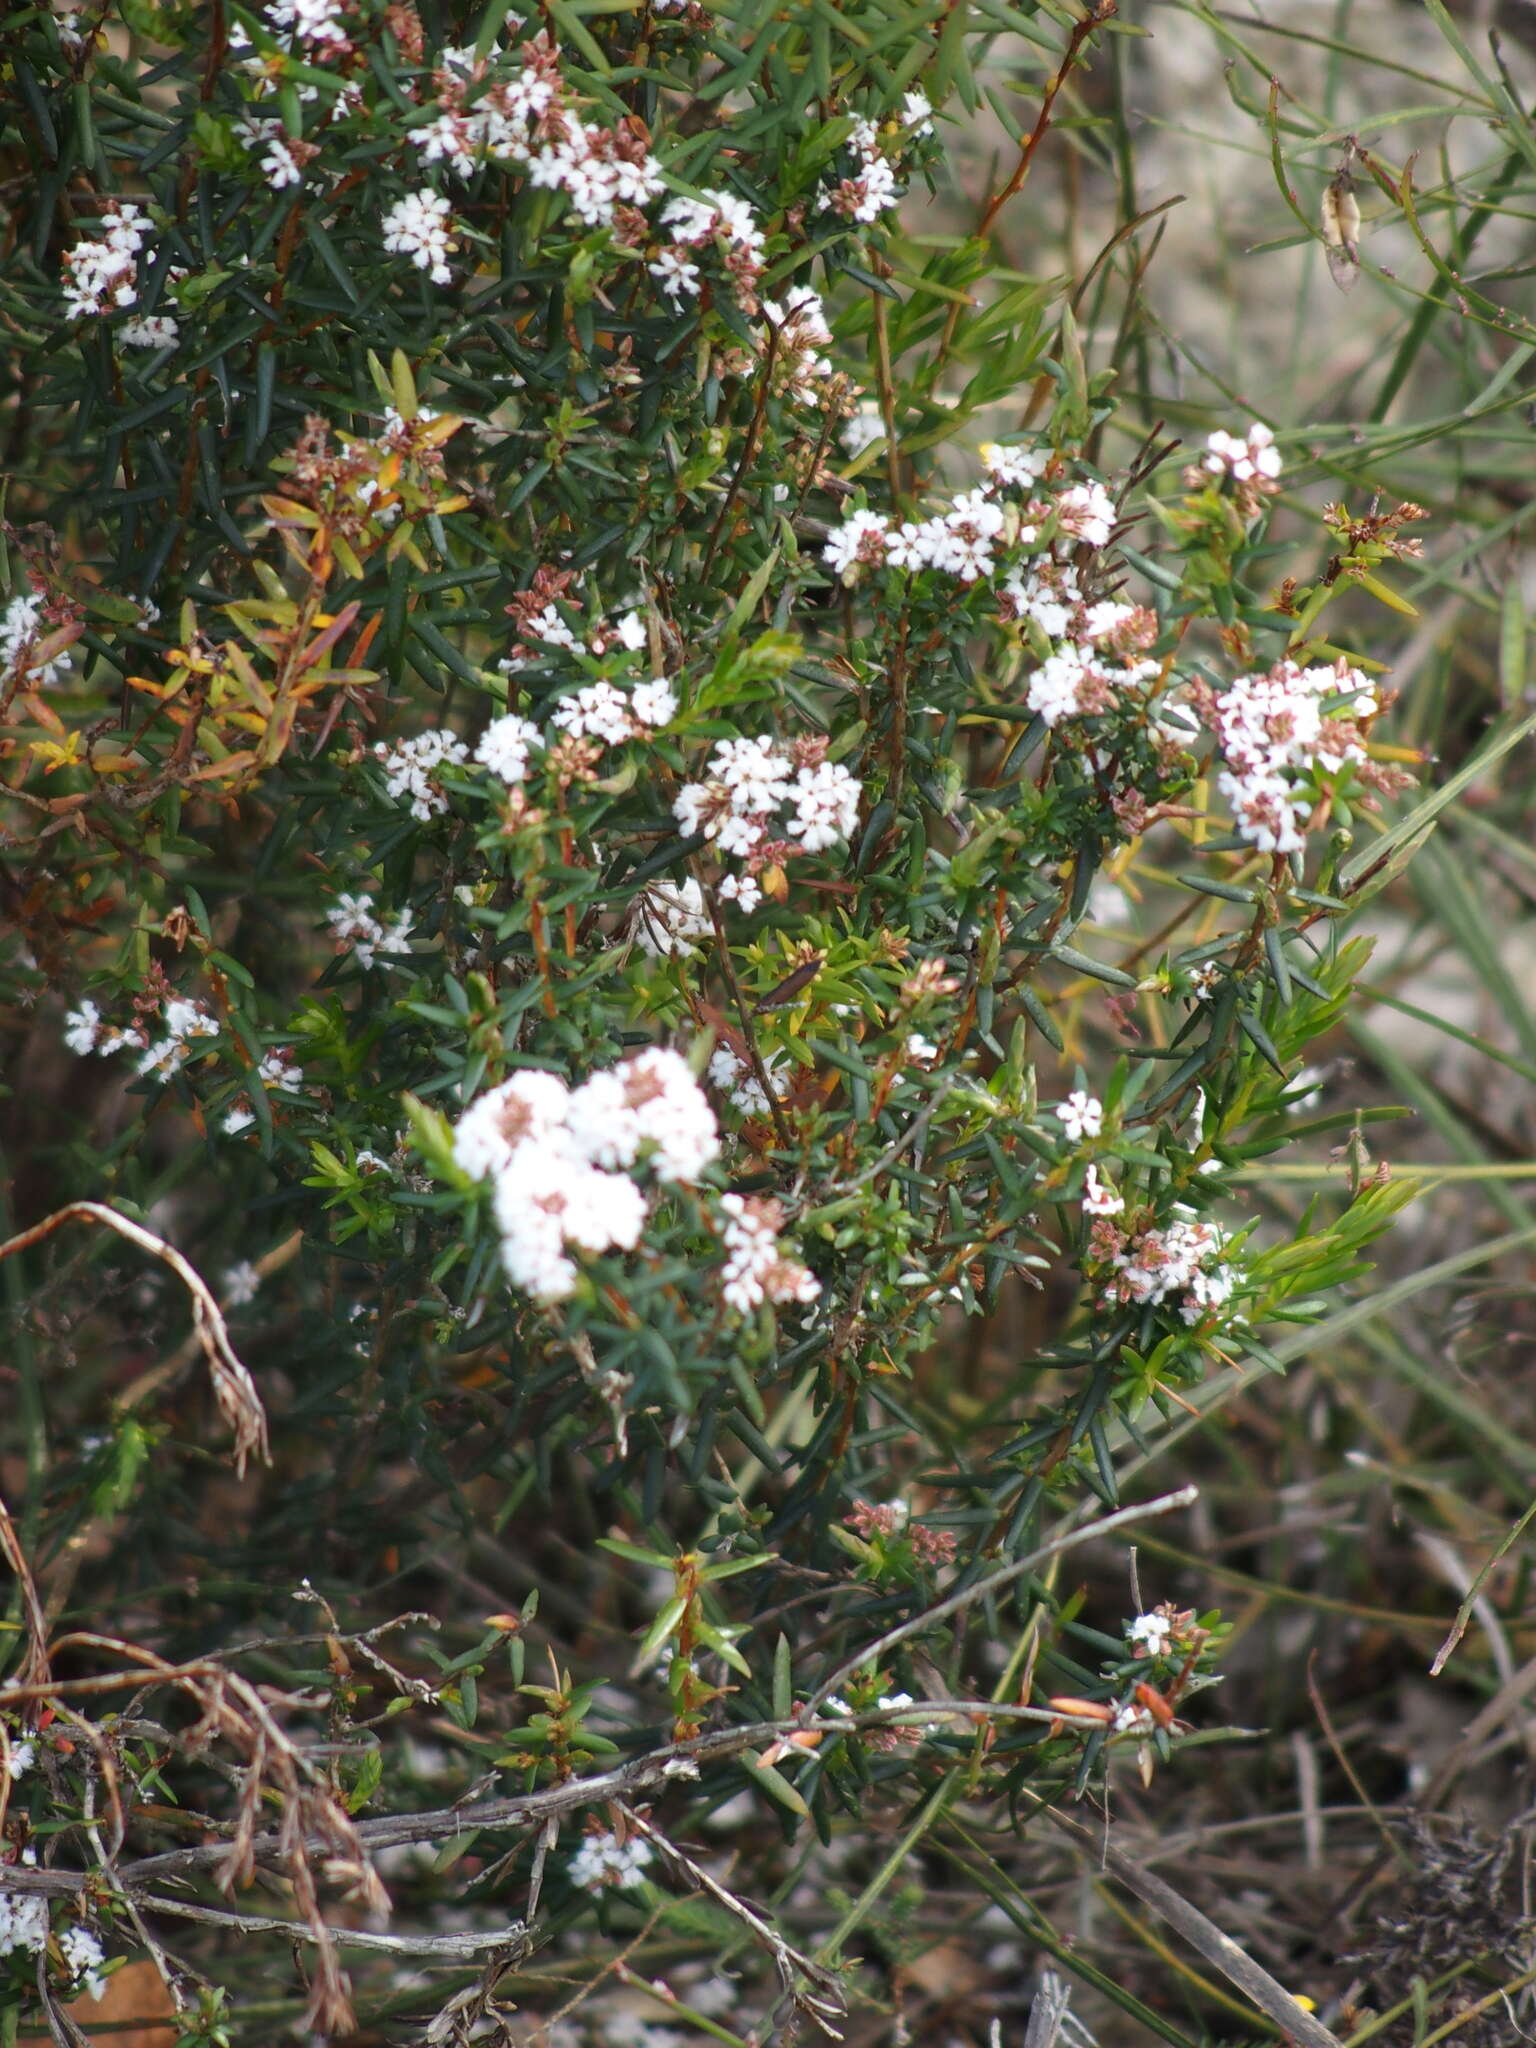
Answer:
[{"xmin": 0, "ymin": 0, "xmax": 1441, "ymax": 2040}]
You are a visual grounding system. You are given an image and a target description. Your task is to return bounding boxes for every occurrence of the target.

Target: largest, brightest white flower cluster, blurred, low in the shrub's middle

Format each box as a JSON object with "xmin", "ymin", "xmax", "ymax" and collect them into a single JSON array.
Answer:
[{"xmin": 453, "ymin": 1047, "xmax": 721, "ymax": 1300}]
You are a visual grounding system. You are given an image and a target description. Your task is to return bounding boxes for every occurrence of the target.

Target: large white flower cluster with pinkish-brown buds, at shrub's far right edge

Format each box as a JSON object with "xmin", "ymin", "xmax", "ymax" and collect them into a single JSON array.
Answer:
[{"xmin": 1210, "ymin": 657, "xmax": 1380, "ymax": 854}]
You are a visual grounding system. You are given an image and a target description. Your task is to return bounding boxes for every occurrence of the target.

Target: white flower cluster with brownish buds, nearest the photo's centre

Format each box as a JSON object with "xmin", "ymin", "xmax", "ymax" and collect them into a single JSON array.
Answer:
[{"xmin": 672, "ymin": 737, "xmax": 862, "ymax": 892}]
